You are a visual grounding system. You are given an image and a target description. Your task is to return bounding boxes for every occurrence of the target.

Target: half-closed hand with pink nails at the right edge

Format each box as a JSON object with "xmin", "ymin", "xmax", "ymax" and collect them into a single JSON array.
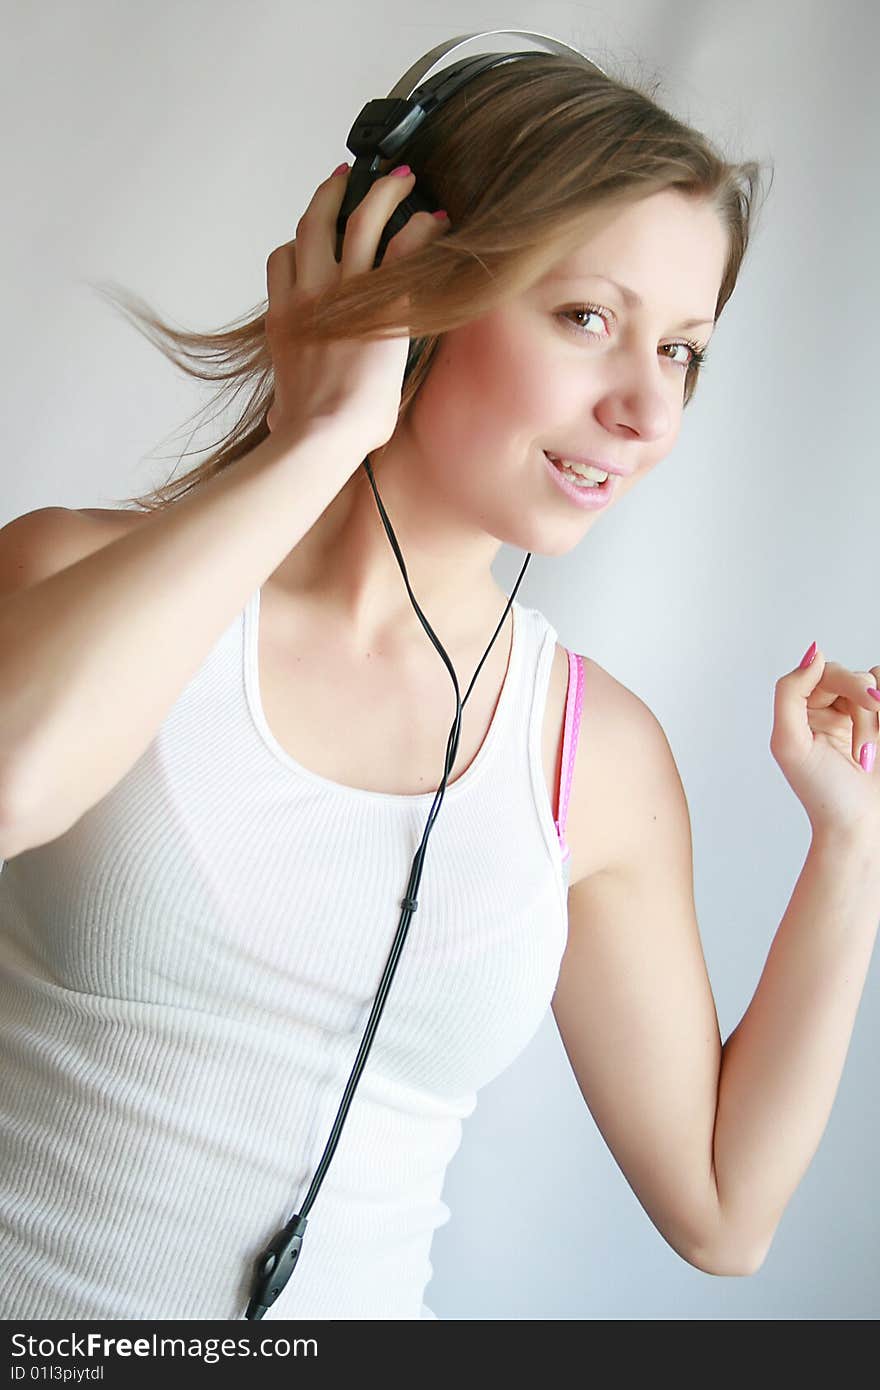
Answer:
[{"xmin": 770, "ymin": 651, "xmax": 880, "ymax": 853}]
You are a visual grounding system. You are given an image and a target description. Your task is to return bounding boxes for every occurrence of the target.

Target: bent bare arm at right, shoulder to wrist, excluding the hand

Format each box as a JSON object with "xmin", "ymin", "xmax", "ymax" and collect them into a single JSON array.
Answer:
[{"xmin": 553, "ymin": 672, "xmax": 880, "ymax": 1276}]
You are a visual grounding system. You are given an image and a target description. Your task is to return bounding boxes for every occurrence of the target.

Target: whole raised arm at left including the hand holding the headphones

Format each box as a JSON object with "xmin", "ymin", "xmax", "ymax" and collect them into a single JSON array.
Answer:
[{"xmin": 0, "ymin": 157, "xmax": 445, "ymax": 858}]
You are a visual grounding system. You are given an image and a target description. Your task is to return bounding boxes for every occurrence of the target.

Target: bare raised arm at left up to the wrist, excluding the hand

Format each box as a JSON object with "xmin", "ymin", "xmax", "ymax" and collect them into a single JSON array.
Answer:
[{"xmin": 0, "ymin": 421, "xmax": 361, "ymax": 858}]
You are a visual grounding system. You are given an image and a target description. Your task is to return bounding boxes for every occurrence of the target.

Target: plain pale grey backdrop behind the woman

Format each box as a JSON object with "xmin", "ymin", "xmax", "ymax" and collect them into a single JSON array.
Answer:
[{"xmin": 0, "ymin": 0, "xmax": 880, "ymax": 1319}]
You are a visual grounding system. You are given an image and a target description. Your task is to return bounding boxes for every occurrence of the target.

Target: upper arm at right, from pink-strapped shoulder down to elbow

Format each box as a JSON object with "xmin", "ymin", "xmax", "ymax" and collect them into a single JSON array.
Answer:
[{"xmin": 552, "ymin": 678, "xmax": 722, "ymax": 1275}]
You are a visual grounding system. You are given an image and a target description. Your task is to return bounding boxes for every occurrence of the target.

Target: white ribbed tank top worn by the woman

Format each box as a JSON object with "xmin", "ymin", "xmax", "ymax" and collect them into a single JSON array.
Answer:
[{"xmin": 0, "ymin": 591, "xmax": 582, "ymax": 1321}]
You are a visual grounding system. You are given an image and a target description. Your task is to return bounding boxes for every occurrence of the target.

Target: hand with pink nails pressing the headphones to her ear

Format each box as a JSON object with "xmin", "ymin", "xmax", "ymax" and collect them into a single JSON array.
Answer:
[{"xmin": 266, "ymin": 165, "xmax": 449, "ymax": 457}]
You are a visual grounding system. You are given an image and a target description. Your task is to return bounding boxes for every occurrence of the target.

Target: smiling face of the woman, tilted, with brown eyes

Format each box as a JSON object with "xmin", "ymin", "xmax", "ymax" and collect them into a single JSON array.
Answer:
[{"xmin": 389, "ymin": 189, "xmax": 727, "ymax": 555}]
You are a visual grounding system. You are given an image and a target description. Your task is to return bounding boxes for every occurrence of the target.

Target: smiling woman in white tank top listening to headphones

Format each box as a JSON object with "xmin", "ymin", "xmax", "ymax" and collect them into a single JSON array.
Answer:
[{"xmin": 0, "ymin": 54, "xmax": 880, "ymax": 1319}]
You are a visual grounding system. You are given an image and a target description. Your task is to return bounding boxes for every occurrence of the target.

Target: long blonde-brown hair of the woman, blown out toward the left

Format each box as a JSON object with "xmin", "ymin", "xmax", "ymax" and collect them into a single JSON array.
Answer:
[{"xmin": 92, "ymin": 53, "xmax": 762, "ymax": 512}]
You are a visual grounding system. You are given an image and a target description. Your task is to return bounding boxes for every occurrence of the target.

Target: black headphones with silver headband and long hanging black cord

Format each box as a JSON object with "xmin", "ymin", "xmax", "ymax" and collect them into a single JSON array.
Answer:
[{"xmin": 245, "ymin": 29, "xmax": 606, "ymax": 1319}]
